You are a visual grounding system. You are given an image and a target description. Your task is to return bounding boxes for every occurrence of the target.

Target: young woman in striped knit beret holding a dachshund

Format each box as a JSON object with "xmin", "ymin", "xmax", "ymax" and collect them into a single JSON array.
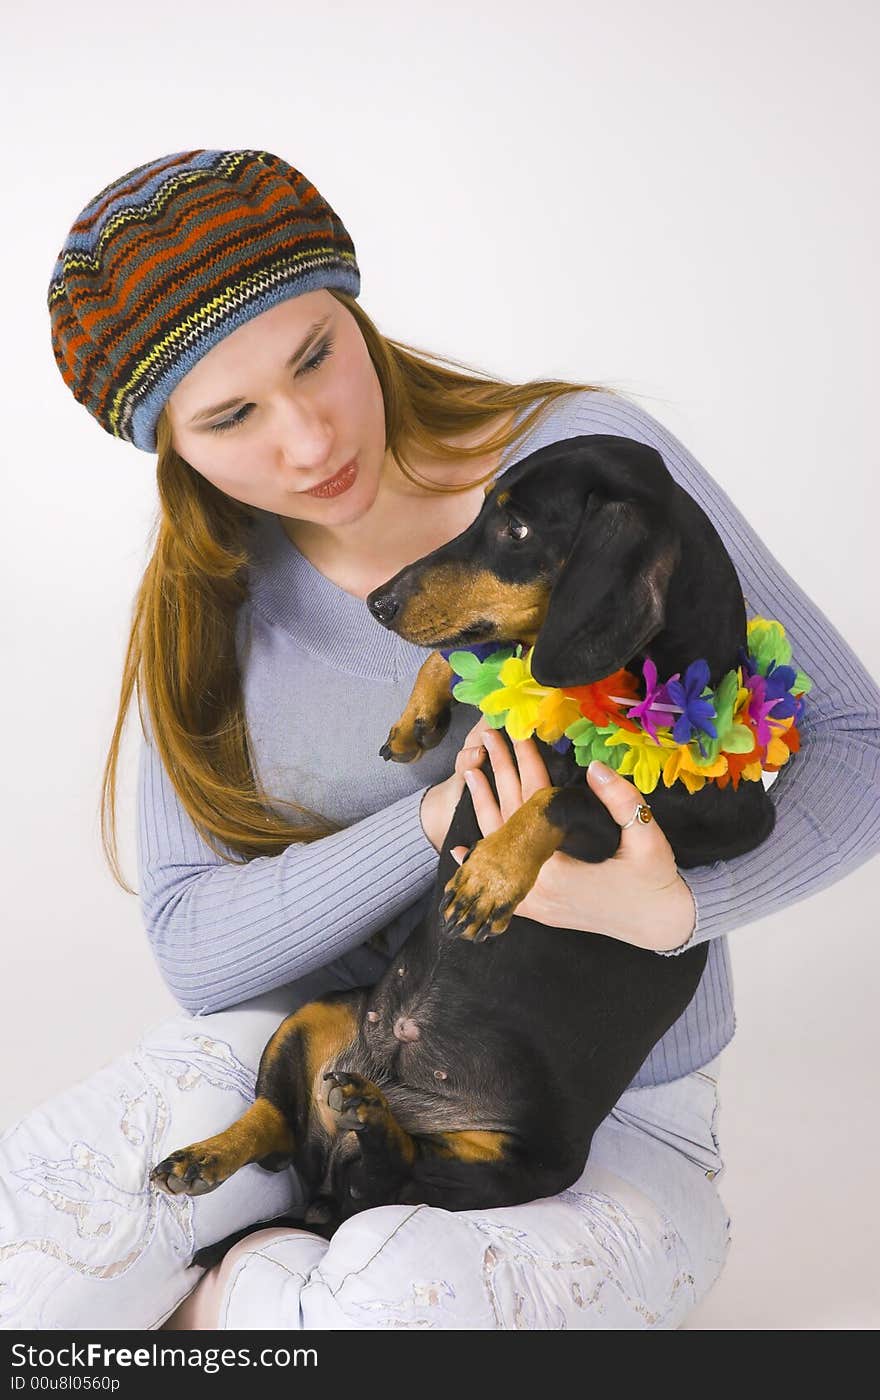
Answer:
[{"xmin": 0, "ymin": 151, "xmax": 880, "ymax": 1329}]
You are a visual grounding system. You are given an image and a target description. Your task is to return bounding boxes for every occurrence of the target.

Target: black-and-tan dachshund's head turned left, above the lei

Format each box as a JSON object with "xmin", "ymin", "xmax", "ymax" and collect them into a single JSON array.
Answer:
[{"xmin": 367, "ymin": 434, "xmax": 680, "ymax": 686}]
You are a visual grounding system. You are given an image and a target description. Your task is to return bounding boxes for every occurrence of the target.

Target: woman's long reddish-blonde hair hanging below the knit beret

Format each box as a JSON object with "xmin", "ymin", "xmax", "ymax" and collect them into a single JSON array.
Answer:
[{"xmin": 101, "ymin": 291, "xmax": 614, "ymax": 893}]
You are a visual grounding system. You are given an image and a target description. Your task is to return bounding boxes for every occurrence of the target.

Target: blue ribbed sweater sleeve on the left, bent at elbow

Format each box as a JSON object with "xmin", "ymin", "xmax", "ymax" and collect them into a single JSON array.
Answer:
[{"xmin": 137, "ymin": 738, "xmax": 437, "ymax": 1015}]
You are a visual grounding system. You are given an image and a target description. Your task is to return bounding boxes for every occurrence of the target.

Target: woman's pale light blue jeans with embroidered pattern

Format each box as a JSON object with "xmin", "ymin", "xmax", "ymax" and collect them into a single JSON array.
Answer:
[{"xmin": 0, "ymin": 969, "xmax": 729, "ymax": 1330}]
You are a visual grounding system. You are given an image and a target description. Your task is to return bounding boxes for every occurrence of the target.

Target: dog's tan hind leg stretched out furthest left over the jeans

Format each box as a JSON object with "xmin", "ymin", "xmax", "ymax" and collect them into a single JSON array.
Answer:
[{"xmin": 150, "ymin": 991, "xmax": 365, "ymax": 1196}]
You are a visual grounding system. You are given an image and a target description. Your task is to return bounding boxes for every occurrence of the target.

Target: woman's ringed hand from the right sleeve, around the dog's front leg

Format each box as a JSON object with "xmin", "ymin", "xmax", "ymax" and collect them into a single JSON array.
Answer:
[{"xmin": 452, "ymin": 718, "xmax": 697, "ymax": 952}]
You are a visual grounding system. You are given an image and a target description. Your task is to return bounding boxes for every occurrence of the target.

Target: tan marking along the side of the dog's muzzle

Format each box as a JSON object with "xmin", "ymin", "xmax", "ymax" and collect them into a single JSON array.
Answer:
[{"xmin": 393, "ymin": 563, "xmax": 550, "ymax": 647}]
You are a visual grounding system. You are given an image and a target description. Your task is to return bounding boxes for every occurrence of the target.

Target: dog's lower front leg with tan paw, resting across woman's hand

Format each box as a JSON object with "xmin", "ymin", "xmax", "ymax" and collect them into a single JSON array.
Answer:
[{"xmin": 439, "ymin": 780, "xmax": 620, "ymax": 942}]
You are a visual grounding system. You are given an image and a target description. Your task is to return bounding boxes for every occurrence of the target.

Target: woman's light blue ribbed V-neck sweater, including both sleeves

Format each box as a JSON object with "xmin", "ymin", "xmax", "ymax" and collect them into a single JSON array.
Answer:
[{"xmin": 139, "ymin": 391, "xmax": 880, "ymax": 1086}]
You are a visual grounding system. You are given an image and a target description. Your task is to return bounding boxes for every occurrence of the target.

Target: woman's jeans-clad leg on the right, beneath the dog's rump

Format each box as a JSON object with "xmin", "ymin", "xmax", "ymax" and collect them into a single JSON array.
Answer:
[{"xmin": 214, "ymin": 1179, "xmax": 707, "ymax": 1330}]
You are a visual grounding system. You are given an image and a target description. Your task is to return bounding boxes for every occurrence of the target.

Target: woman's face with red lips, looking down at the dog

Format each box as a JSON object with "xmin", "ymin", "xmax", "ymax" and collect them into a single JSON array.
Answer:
[{"xmin": 166, "ymin": 290, "xmax": 385, "ymax": 526}]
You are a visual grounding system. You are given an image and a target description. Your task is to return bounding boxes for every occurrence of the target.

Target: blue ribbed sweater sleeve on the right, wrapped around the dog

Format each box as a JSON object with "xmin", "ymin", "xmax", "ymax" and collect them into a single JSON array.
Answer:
[{"xmin": 562, "ymin": 393, "xmax": 880, "ymax": 956}]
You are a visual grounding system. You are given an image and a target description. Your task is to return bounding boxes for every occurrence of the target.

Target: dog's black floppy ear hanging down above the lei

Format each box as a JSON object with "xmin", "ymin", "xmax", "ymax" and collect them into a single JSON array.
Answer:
[{"xmin": 532, "ymin": 491, "xmax": 679, "ymax": 686}]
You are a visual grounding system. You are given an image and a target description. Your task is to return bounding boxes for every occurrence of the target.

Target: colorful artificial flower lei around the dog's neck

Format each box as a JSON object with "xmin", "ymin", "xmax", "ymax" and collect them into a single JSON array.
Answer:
[{"xmin": 442, "ymin": 617, "xmax": 813, "ymax": 792}]
